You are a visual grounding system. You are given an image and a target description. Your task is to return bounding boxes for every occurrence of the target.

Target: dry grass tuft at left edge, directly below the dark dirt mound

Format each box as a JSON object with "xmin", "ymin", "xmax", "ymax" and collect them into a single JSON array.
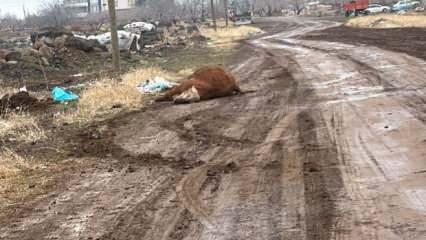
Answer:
[{"xmin": 0, "ymin": 113, "xmax": 46, "ymax": 142}]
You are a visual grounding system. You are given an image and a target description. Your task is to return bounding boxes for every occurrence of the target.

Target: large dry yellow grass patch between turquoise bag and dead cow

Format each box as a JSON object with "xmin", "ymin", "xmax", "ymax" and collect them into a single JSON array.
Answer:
[{"xmin": 55, "ymin": 67, "xmax": 175, "ymax": 123}]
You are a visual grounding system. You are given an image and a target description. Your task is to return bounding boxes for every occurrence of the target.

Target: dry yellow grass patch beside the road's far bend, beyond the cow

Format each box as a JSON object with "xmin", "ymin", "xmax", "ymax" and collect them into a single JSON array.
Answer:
[{"xmin": 200, "ymin": 22, "xmax": 262, "ymax": 47}]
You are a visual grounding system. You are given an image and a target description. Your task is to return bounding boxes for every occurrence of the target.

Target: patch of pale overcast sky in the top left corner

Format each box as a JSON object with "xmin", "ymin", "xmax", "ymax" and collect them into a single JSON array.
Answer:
[{"xmin": 0, "ymin": 0, "xmax": 46, "ymax": 17}]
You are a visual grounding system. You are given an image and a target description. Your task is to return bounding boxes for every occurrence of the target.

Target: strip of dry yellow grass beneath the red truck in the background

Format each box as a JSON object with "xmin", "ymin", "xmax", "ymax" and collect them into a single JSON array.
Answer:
[{"xmin": 345, "ymin": 14, "xmax": 426, "ymax": 28}]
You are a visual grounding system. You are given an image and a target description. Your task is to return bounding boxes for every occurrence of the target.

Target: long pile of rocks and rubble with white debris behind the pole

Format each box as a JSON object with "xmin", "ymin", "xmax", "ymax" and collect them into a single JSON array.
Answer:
[{"xmin": 0, "ymin": 22, "xmax": 206, "ymax": 81}]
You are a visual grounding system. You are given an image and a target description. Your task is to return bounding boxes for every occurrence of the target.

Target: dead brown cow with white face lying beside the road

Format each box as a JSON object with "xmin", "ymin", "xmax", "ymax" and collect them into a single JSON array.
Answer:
[{"xmin": 157, "ymin": 67, "xmax": 241, "ymax": 103}]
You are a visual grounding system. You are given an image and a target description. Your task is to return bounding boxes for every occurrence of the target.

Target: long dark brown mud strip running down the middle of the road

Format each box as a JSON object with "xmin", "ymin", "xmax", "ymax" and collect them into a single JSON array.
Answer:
[{"xmin": 250, "ymin": 40, "xmax": 343, "ymax": 240}]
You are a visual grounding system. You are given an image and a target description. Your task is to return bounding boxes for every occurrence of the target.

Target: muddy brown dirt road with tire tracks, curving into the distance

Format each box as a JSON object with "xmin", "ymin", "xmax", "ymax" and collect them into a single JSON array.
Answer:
[{"xmin": 0, "ymin": 18, "xmax": 426, "ymax": 240}]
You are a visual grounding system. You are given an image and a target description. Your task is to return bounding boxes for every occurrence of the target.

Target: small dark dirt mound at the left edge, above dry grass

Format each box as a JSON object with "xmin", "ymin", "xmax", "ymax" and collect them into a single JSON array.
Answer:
[{"xmin": 0, "ymin": 92, "xmax": 39, "ymax": 114}]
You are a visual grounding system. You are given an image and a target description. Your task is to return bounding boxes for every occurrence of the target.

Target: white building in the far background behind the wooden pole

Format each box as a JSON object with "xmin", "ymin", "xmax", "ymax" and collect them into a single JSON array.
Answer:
[{"xmin": 64, "ymin": 0, "xmax": 136, "ymax": 17}]
